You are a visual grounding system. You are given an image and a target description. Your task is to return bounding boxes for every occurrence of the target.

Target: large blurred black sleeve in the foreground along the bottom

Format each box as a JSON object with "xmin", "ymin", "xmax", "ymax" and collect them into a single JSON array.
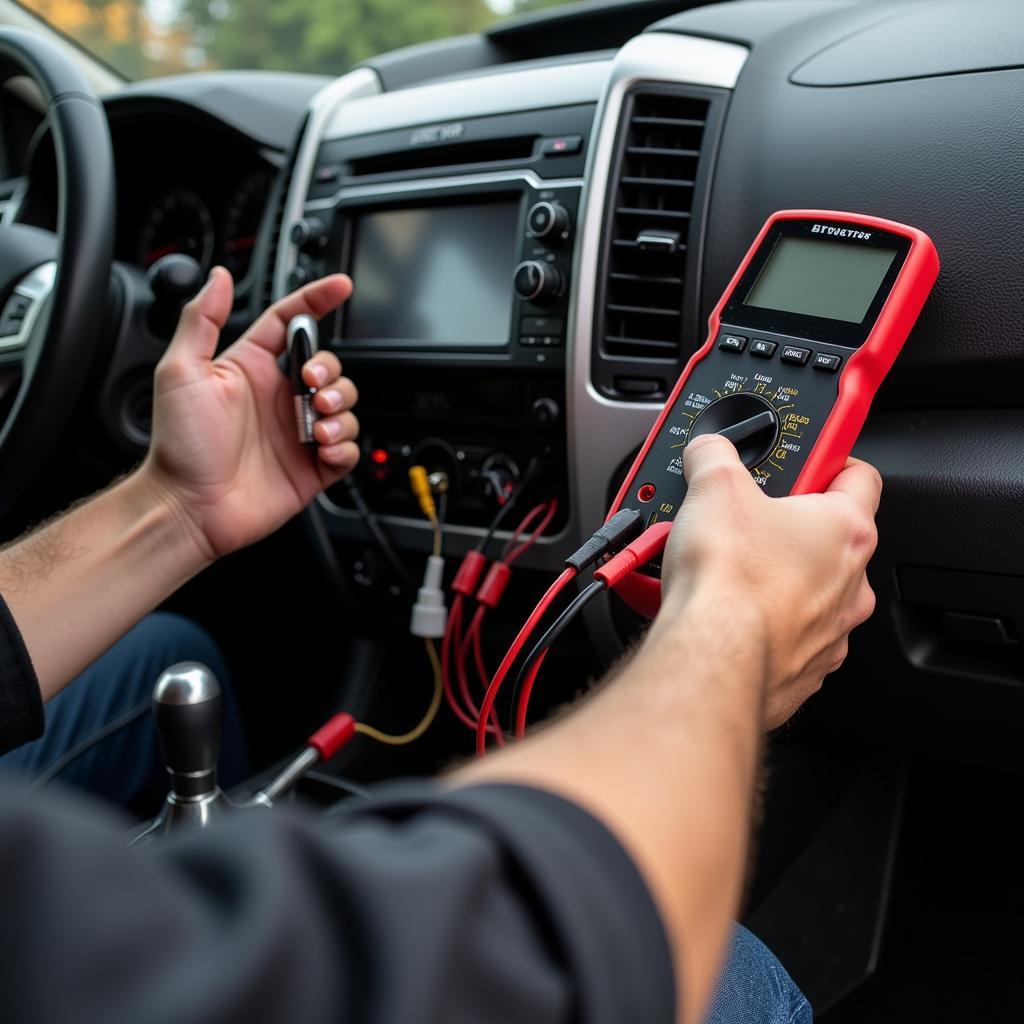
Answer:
[{"xmin": 0, "ymin": 785, "xmax": 675, "ymax": 1024}]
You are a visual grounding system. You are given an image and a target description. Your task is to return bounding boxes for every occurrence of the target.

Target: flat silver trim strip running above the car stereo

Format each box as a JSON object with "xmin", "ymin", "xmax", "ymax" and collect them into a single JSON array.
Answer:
[{"xmin": 324, "ymin": 60, "xmax": 610, "ymax": 139}]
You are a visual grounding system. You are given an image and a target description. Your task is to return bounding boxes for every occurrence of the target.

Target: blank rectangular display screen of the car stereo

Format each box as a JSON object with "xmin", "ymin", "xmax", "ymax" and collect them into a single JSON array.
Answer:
[{"xmin": 344, "ymin": 198, "xmax": 519, "ymax": 346}]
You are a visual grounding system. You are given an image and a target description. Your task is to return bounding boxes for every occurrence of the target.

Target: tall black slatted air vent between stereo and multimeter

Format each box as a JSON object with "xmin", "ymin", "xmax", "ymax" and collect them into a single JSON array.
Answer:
[{"xmin": 594, "ymin": 86, "xmax": 717, "ymax": 397}]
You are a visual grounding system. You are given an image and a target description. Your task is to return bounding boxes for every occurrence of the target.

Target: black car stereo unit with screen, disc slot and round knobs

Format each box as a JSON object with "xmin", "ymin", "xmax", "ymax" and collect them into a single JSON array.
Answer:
[{"xmin": 291, "ymin": 100, "xmax": 593, "ymax": 370}]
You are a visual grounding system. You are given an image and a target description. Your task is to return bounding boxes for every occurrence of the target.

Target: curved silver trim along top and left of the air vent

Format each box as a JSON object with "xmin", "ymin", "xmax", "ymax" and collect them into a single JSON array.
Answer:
[{"xmin": 566, "ymin": 32, "xmax": 748, "ymax": 657}]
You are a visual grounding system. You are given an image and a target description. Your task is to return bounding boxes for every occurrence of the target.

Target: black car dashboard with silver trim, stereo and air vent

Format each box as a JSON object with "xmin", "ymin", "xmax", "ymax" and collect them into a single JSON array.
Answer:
[{"xmin": 8, "ymin": 0, "xmax": 1024, "ymax": 764}]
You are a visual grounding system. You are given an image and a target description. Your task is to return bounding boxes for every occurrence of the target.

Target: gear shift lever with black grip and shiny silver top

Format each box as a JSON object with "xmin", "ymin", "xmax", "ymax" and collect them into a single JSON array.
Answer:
[{"xmin": 133, "ymin": 662, "xmax": 231, "ymax": 843}]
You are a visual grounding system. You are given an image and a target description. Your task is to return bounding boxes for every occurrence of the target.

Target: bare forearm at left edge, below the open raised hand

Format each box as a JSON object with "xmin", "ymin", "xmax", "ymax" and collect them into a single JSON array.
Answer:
[{"xmin": 0, "ymin": 473, "xmax": 205, "ymax": 700}]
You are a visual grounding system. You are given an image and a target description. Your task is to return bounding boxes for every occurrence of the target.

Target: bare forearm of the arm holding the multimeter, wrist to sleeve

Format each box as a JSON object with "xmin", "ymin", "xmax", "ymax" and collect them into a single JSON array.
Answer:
[{"xmin": 454, "ymin": 593, "xmax": 764, "ymax": 1021}]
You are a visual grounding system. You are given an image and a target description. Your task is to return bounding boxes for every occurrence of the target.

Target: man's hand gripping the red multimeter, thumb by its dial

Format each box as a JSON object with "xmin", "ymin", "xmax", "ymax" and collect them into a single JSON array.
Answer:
[{"xmin": 658, "ymin": 434, "xmax": 882, "ymax": 729}]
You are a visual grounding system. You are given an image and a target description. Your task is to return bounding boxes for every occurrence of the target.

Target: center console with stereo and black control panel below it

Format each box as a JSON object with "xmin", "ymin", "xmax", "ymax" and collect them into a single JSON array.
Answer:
[{"xmin": 287, "ymin": 89, "xmax": 594, "ymax": 537}]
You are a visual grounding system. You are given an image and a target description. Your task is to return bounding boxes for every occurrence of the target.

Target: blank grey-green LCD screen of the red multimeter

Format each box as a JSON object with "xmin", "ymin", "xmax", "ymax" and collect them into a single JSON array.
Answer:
[{"xmin": 743, "ymin": 234, "xmax": 897, "ymax": 324}]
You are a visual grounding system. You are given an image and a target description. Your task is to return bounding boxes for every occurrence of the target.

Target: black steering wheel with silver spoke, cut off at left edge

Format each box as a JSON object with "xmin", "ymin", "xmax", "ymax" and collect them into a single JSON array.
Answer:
[{"xmin": 0, "ymin": 28, "xmax": 116, "ymax": 515}]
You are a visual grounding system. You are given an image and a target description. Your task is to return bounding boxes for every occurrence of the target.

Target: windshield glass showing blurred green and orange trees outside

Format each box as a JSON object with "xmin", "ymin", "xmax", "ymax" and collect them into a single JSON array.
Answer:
[{"xmin": 22, "ymin": 0, "xmax": 581, "ymax": 79}]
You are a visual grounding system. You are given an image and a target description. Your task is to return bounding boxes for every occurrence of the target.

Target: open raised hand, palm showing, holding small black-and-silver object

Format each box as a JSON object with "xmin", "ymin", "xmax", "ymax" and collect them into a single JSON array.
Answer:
[{"xmin": 139, "ymin": 267, "xmax": 359, "ymax": 560}]
